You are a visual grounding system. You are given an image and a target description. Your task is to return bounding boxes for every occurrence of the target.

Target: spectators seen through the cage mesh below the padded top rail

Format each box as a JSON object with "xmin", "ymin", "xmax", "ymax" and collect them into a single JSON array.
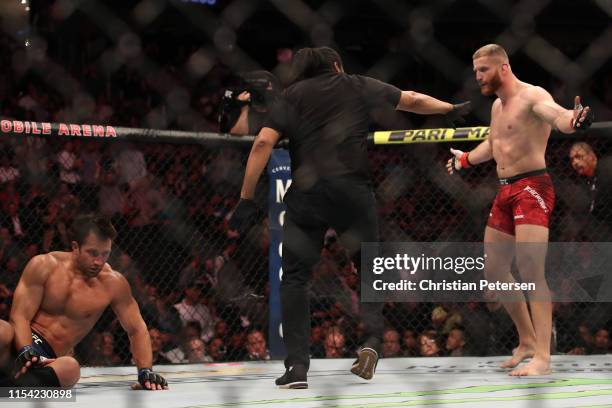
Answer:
[{"xmin": 0, "ymin": 133, "xmax": 612, "ymax": 365}]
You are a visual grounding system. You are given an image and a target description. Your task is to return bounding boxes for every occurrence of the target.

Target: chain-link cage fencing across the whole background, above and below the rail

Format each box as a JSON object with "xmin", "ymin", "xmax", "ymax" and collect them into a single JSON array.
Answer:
[{"xmin": 0, "ymin": 0, "xmax": 612, "ymax": 365}]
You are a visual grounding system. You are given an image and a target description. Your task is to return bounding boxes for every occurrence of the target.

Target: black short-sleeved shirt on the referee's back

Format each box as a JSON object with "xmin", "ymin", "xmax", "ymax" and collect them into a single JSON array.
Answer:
[{"xmin": 264, "ymin": 72, "xmax": 401, "ymax": 190}]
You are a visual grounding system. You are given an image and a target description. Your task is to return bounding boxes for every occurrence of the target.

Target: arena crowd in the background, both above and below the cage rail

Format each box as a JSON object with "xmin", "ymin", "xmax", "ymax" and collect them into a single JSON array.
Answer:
[{"xmin": 0, "ymin": 1, "xmax": 612, "ymax": 365}]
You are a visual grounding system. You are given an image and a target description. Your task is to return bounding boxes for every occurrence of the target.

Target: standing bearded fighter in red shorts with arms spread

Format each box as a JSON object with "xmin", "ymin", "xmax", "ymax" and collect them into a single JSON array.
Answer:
[{"xmin": 447, "ymin": 44, "xmax": 593, "ymax": 376}]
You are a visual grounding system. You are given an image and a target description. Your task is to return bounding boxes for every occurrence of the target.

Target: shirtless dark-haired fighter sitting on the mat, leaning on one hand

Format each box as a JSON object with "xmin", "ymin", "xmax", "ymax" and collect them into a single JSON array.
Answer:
[{"xmin": 0, "ymin": 215, "xmax": 168, "ymax": 390}]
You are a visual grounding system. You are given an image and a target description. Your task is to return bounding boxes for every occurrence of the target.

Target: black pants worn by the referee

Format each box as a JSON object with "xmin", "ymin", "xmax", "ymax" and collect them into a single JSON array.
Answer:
[{"xmin": 280, "ymin": 180, "xmax": 384, "ymax": 369}]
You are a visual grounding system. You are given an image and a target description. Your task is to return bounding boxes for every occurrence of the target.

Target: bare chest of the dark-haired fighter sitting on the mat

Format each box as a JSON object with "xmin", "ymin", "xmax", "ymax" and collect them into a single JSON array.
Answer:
[{"xmin": 41, "ymin": 273, "xmax": 110, "ymax": 320}]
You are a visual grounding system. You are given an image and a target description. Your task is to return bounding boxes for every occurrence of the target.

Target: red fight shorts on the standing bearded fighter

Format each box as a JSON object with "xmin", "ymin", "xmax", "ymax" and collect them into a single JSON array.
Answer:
[{"xmin": 487, "ymin": 169, "xmax": 555, "ymax": 235}]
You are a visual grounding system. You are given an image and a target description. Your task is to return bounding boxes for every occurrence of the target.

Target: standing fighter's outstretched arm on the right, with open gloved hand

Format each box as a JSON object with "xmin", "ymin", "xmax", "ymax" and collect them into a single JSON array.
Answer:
[{"xmin": 525, "ymin": 86, "xmax": 590, "ymax": 133}]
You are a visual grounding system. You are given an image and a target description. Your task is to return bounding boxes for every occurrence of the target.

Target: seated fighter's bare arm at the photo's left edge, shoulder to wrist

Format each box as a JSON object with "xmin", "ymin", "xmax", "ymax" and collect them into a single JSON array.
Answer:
[{"xmin": 10, "ymin": 255, "xmax": 50, "ymax": 350}]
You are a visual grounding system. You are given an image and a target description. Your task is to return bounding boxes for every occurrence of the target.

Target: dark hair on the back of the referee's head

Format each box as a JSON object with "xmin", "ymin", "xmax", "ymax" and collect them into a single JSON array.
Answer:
[{"xmin": 291, "ymin": 47, "xmax": 343, "ymax": 82}]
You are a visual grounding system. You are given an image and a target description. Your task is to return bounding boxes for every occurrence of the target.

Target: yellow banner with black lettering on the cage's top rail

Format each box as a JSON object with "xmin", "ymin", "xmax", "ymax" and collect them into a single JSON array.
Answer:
[{"xmin": 374, "ymin": 126, "xmax": 489, "ymax": 144}]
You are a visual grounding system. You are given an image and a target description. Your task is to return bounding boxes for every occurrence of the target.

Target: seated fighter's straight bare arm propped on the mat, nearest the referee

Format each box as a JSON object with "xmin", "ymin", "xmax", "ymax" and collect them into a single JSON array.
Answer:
[{"xmin": 111, "ymin": 272, "xmax": 153, "ymax": 369}]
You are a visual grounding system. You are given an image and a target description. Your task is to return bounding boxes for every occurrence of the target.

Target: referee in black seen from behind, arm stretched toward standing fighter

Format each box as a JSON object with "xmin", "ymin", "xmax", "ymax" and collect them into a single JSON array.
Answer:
[{"xmin": 231, "ymin": 47, "xmax": 470, "ymax": 388}]
